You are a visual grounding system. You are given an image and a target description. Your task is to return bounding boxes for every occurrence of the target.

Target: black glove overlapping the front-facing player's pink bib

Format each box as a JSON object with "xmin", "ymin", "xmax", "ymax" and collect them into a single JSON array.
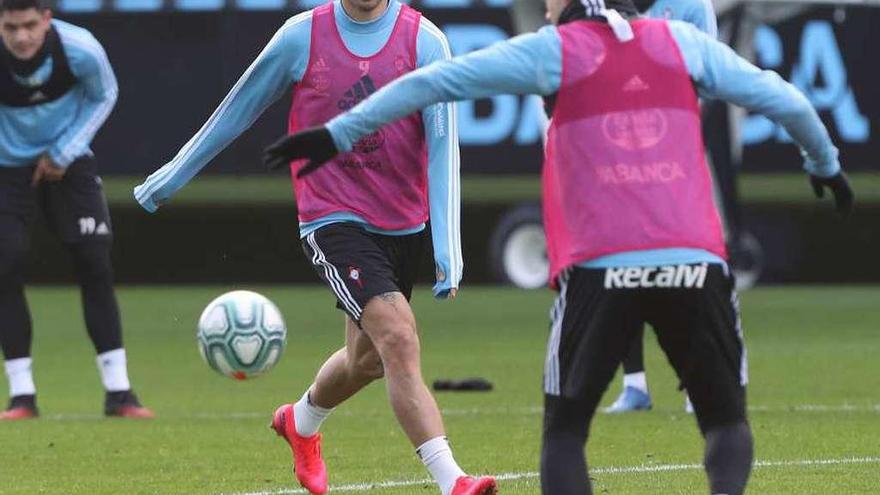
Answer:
[{"xmin": 263, "ymin": 126, "xmax": 339, "ymax": 177}]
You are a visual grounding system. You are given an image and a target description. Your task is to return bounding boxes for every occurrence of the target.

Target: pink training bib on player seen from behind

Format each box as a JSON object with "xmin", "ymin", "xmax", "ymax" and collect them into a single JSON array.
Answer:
[{"xmin": 543, "ymin": 20, "xmax": 727, "ymax": 286}]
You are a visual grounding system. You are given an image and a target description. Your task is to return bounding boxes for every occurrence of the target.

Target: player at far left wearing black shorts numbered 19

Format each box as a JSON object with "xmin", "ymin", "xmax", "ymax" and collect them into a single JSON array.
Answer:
[{"xmin": 0, "ymin": 0, "xmax": 152, "ymax": 419}]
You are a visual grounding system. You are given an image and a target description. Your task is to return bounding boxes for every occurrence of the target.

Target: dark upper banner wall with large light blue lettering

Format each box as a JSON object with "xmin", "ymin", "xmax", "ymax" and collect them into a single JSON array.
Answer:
[{"xmin": 56, "ymin": 0, "xmax": 880, "ymax": 176}]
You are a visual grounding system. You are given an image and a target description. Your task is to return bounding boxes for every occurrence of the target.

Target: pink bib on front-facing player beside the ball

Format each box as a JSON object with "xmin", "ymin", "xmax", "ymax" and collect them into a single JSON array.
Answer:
[{"xmin": 289, "ymin": 2, "xmax": 428, "ymax": 230}]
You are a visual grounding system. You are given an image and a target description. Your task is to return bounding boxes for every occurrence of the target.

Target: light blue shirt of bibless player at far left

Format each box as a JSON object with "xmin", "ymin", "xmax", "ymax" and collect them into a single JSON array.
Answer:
[{"xmin": 0, "ymin": 19, "xmax": 119, "ymax": 167}]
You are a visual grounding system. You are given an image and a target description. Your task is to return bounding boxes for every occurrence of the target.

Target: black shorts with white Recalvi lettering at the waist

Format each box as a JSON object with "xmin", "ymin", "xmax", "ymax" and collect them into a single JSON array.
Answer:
[{"xmin": 544, "ymin": 264, "xmax": 747, "ymax": 430}]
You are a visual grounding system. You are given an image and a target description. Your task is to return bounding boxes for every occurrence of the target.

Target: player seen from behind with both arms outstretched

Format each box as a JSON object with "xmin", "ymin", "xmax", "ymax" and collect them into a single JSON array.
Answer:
[{"xmin": 267, "ymin": 0, "xmax": 853, "ymax": 495}]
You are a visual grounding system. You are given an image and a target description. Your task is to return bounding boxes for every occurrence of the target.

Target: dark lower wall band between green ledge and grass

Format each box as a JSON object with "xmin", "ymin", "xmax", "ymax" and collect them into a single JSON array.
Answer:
[{"xmin": 22, "ymin": 202, "xmax": 880, "ymax": 285}]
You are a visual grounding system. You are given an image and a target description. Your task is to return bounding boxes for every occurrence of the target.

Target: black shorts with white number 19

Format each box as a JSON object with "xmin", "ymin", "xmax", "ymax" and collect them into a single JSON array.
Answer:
[{"xmin": 0, "ymin": 157, "xmax": 113, "ymax": 252}]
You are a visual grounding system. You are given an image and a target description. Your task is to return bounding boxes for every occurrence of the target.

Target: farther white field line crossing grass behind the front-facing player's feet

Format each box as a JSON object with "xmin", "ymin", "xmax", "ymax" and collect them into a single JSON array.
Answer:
[{"xmin": 42, "ymin": 404, "xmax": 880, "ymax": 421}]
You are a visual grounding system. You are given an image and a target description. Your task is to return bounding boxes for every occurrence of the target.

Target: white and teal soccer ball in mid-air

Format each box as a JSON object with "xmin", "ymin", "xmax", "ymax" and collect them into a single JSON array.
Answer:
[{"xmin": 197, "ymin": 290, "xmax": 287, "ymax": 380}]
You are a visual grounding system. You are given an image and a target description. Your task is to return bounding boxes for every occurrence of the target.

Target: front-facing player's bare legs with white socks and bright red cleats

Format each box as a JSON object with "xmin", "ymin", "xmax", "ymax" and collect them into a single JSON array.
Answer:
[{"xmin": 273, "ymin": 292, "xmax": 496, "ymax": 495}]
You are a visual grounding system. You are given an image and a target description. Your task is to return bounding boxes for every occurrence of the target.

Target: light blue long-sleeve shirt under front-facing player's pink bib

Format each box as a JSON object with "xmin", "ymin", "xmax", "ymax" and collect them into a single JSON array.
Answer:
[{"xmin": 134, "ymin": 0, "xmax": 463, "ymax": 297}]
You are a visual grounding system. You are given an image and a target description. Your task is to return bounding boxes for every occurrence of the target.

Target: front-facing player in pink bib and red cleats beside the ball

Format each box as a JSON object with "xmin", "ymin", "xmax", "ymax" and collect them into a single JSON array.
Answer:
[{"xmin": 135, "ymin": 0, "xmax": 496, "ymax": 495}]
